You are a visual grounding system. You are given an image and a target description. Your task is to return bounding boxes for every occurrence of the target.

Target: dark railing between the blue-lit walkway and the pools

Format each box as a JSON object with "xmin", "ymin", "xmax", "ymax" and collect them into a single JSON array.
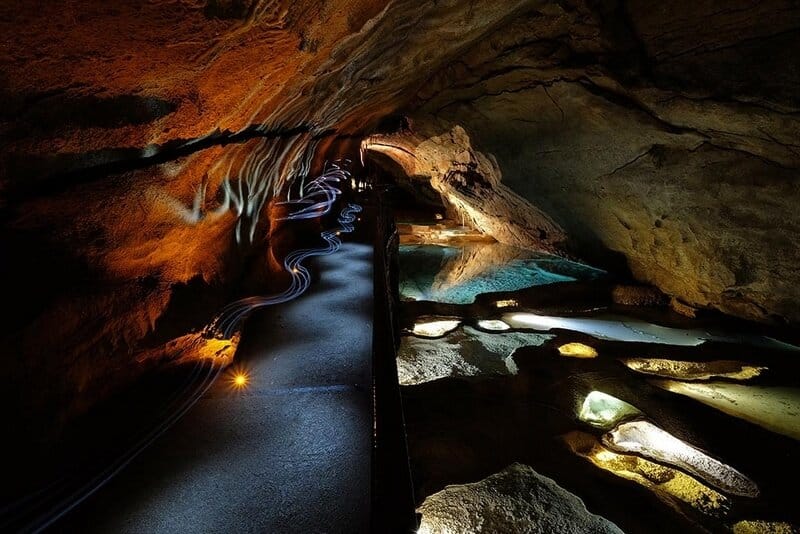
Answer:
[{"xmin": 372, "ymin": 193, "xmax": 417, "ymax": 534}]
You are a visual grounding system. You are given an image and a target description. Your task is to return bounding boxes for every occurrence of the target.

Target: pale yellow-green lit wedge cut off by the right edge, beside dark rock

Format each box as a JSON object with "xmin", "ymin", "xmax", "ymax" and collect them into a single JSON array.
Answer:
[{"xmin": 652, "ymin": 380, "xmax": 800, "ymax": 440}]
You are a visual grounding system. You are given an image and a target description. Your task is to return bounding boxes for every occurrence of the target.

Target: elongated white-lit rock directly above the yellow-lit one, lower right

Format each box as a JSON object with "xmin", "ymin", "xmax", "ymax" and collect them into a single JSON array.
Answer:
[{"xmin": 603, "ymin": 421, "xmax": 759, "ymax": 497}]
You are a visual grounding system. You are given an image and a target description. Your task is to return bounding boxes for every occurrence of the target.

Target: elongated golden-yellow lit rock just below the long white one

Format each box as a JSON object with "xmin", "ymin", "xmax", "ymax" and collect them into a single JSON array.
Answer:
[{"xmin": 564, "ymin": 432, "xmax": 731, "ymax": 516}]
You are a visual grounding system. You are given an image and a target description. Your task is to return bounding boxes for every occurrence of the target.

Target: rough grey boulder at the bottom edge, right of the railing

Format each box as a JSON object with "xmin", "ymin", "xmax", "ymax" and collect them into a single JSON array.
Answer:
[{"xmin": 417, "ymin": 464, "xmax": 622, "ymax": 534}]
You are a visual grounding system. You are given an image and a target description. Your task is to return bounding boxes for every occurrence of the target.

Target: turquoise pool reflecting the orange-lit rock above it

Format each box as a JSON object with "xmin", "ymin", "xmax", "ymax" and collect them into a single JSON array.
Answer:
[{"xmin": 400, "ymin": 243, "xmax": 605, "ymax": 304}]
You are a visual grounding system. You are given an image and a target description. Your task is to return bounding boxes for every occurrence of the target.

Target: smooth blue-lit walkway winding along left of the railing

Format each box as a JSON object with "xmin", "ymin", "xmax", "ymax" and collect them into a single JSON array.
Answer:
[{"xmin": 54, "ymin": 243, "xmax": 373, "ymax": 533}]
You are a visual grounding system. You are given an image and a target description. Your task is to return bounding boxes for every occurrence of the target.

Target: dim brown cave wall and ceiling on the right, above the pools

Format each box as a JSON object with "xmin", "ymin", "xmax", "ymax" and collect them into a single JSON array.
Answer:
[{"xmin": 384, "ymin": 1, "xmax": 800, "ymax": 322}]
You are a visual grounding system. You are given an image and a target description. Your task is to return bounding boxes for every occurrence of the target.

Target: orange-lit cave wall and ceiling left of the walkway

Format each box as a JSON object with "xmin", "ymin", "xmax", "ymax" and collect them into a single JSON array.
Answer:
[{"xmin": 0, "ymin": 0, "xmax": 544, "ymax": 436}]
